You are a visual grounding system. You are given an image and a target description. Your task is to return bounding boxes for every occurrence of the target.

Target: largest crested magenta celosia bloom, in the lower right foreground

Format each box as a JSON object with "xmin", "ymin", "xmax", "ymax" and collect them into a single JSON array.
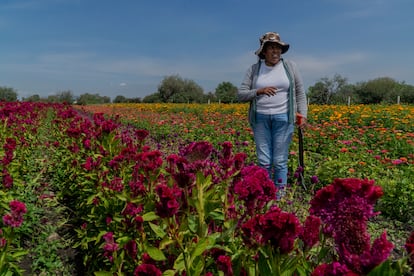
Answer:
[{"xmin": 310, "ymin": 178, "xmax": 393, "ymax": 274}]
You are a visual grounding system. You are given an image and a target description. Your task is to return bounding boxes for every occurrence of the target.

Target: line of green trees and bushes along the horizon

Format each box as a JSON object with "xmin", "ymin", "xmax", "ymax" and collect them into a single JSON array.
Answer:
[{"xmin": 0, "ymin": 74, "xmax": 414, "ymax": 105}]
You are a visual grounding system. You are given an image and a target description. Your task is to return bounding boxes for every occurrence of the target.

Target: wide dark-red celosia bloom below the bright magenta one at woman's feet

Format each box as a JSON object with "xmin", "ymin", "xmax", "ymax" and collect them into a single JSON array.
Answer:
[{"xmin": 242, "ymin": 206, "xmax": 302, "ymax": 254}]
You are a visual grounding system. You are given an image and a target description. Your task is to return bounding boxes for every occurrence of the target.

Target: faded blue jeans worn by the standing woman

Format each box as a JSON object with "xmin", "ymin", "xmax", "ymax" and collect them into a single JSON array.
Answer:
[{"xmin": 253, "ymin": 113, "xmax": 294, "ymax": 188}]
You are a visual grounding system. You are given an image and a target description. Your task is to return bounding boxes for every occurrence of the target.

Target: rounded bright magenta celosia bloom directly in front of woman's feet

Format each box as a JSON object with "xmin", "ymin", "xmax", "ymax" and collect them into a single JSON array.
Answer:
[{"xmin": 234, "ymin": 166, "xmax": 276, "ymax": 214}]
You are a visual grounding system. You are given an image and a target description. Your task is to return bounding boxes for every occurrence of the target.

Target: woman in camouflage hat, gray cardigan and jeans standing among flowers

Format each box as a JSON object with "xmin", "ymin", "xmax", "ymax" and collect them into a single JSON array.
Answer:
[{"xmin": 238, "ymin": 32, "xmax": 308, "ymax": 195}]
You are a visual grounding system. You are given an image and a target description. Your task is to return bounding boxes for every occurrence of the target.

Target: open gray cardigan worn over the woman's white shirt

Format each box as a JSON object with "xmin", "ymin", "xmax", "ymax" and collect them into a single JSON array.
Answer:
[{"xmin": 237, "ymin": 59, "xmax": 308, "ymax": 127}]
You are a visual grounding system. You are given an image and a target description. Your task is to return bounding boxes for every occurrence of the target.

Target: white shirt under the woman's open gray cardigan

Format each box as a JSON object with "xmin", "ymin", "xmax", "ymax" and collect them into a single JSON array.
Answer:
[{"xmin": 256, "ymin": 61, "xmax": 289, "ymax": 115}]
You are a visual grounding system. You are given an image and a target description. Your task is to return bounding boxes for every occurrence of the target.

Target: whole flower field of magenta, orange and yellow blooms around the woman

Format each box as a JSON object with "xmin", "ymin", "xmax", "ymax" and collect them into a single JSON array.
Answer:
[{"xmin": 0, "ymin": 102, "xmax": 414, "ymax": 275}]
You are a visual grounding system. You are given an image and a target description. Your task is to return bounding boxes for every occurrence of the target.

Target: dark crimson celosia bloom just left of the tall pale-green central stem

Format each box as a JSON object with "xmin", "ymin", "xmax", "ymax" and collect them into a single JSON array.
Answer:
[{"xmin": 155, "ymin": 184, "xmax": 182, "ymax": 218}]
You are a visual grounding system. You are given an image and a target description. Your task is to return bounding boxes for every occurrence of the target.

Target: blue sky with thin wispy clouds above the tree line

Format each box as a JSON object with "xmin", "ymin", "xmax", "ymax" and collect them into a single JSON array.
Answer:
[{"xmin": 0, "ymin": 0, "xmax": 414, "ymax": 99}]
